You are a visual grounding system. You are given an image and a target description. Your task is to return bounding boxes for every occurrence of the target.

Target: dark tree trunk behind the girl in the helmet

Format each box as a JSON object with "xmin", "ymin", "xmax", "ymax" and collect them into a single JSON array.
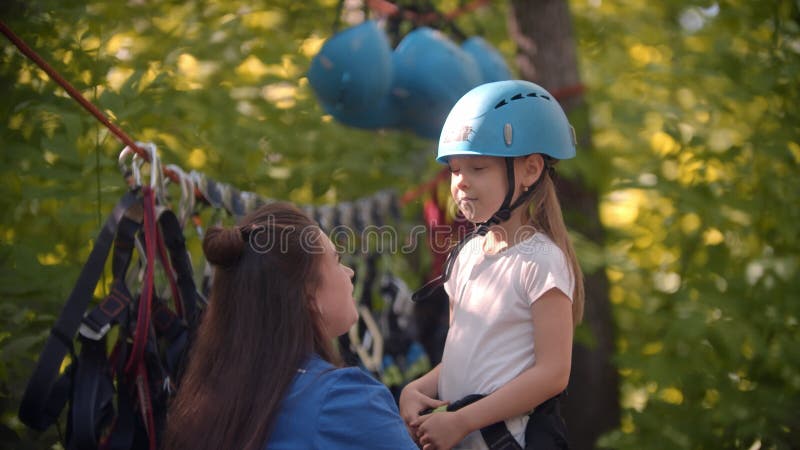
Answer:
[{"xmin": 508, "ymin": 0, "xmax": 620, "ymax": 450}]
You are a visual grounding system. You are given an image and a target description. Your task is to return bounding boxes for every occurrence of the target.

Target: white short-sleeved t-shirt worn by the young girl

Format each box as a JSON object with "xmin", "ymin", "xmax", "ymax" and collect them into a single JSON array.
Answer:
[{"xmin": 439, "ymin": 233, "xmax": 575, "ymax": 449}]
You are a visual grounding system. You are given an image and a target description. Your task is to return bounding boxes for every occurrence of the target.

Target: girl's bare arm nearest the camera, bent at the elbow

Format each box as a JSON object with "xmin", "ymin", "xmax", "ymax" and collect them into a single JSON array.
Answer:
[{"xmin": 411, "ymin": 288, "xmax": 573, "ymax": 448}]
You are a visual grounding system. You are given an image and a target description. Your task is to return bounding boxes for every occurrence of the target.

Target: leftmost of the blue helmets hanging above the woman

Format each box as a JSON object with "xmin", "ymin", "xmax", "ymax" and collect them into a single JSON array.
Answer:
[{"xmin": 308, "ymin": 20, "xmax": 392, "ymax": 118}]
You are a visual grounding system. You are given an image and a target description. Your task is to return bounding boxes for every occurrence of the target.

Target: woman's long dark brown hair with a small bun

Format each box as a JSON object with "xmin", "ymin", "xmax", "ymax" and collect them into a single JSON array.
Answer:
[{"xmin": 163, "ymin": 203, "xmax": 341, "ymax": 450}]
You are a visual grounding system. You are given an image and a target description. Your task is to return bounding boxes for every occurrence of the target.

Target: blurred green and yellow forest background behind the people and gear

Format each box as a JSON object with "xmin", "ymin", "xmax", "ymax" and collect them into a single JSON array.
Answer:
[{"xmin": 0, "ymin": 0, "xmax": 800, "ymax": 450}]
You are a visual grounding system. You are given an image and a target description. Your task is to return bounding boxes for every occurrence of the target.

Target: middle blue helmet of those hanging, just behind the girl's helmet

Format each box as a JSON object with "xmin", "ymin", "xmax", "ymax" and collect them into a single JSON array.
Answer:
[{"xmin": 391, "ymin": 27, "xmax": 481, "ymax": 139}]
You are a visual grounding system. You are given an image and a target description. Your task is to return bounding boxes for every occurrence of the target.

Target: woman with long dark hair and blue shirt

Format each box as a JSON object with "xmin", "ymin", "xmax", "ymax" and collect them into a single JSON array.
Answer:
[{"xmin": 163, "ymin": 203, "xmax": 417, "ymax": 450}]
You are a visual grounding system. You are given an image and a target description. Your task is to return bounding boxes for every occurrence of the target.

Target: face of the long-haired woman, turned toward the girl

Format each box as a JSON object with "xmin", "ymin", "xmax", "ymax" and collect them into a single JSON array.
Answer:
[{"xmin": 314, "ymin": 230, "xmax": 358, "ymax": 339}]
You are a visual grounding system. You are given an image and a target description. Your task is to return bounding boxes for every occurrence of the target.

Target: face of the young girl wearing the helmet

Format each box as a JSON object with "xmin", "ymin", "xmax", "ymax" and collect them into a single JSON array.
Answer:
[{"xmin": 448, "ymin": 156, "xmax": 508, "ymax": 223}]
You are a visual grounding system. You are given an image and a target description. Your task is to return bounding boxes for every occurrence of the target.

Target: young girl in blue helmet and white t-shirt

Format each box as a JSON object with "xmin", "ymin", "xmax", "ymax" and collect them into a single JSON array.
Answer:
[{"xmin": 400, "ymin": 80, "xmax": 583, "ymax": 450}]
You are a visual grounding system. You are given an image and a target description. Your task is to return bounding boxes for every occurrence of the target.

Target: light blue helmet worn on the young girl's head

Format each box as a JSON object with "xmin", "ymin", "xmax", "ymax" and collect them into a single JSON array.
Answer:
[{"xmin": 436, "ymin": 80, "xmax": 576, "ymax": 163}]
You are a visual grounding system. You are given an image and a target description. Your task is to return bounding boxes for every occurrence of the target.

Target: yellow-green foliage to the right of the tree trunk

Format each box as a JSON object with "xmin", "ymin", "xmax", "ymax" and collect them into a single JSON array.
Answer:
[{"xmin": 573, "ymin": 0, "xmax": 800, "ymax": 449}]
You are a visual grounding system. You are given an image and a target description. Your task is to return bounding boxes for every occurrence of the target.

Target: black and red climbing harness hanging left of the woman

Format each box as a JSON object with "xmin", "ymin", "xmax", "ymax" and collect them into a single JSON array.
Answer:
[{"xmin": 19, "ymin": 180, "xmax": 204, "ymax": 450}]
